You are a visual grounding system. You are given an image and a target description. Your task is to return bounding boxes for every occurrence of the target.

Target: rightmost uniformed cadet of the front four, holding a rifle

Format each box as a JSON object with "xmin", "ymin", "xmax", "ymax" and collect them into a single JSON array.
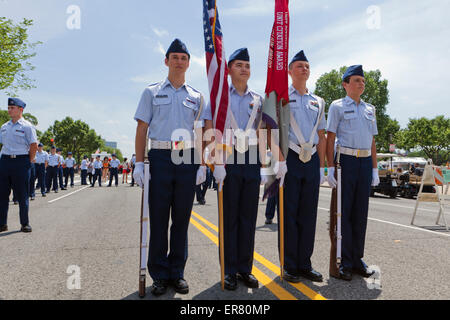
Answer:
[{"xmin": 327, "ymin": 65, "xmax": 379, "ymax": 281}]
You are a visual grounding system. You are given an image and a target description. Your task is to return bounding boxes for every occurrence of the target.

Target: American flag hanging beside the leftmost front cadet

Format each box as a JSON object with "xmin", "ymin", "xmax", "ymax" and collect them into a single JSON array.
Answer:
[{"xmin": 202, "ymin": 0, "xmax": 229, "ymax": 134}]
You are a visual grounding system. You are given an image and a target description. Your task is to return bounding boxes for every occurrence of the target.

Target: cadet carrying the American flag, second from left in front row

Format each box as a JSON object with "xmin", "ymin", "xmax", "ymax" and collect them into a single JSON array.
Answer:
[{"xmin": 208, "ymin": 48, "xmax": 263, "ymax": 290}]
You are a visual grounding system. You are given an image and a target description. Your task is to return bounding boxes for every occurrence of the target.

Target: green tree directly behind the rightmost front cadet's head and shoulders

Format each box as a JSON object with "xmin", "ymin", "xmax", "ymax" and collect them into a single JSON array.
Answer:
[{"xmin": 314, "ymin": 66, "xmax": 400, "ymax": 152}]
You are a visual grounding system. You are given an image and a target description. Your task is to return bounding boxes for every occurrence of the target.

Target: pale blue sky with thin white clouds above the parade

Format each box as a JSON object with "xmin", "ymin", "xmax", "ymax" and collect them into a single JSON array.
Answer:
[{"xmin": 0, "ymin": 0, "xmax": 450, "ymax": 156}]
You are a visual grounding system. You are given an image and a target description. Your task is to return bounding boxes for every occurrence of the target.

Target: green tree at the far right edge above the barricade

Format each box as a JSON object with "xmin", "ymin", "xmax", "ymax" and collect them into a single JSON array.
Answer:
[{"xmin": 398, "ymin": 116, "xmax": 450, "ymax": 165}]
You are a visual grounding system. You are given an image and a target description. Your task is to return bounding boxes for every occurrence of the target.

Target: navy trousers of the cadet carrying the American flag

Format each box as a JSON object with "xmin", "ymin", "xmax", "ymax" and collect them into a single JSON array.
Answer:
[{"xmin": 219, "ymin": 150, "xmax": 261, "ymax": 274}]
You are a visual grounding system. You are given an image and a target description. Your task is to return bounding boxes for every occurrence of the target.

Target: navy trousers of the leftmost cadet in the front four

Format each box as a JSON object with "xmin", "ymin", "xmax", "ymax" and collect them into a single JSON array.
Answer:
[{"xmin": 147, "ymin": 149, "xmax": 199, "ymax": 280}]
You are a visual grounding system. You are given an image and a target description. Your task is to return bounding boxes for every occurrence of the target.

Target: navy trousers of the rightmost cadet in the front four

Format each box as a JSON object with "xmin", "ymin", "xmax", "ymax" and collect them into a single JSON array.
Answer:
[{"xmin": 340, "ymin": 155, "xmax": 372, "ymax": 269}]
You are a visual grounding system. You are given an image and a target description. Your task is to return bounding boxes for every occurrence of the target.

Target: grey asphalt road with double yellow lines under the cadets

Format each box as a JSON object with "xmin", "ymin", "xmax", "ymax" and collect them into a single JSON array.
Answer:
[{"xmin": 0, "ymin": 178, "xmax": 450, "ymax": 300}]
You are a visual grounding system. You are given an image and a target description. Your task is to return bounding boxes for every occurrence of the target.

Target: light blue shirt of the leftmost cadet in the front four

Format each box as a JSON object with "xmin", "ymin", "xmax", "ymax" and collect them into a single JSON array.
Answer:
[{"xmin": 134, "ymin": 79, "xmax": 205, "ymax": 141}]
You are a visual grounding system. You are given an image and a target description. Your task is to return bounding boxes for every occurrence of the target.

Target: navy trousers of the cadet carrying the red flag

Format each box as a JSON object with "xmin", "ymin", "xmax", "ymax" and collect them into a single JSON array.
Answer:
[{"xmin": 278, "ymin": 149, "xmax": 320, "ymax": 274}]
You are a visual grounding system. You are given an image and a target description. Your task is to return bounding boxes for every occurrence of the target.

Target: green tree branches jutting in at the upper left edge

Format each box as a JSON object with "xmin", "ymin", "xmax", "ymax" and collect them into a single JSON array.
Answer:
[{"xmin": 0, "ymin": 17, "xmax": 41, "ymax": 96}]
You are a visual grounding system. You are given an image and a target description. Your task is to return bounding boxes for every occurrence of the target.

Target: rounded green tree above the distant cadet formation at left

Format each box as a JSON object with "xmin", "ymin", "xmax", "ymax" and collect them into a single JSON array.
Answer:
[{"xmin": 41, "ymin": 117, "xmax": 104, "ymax": 163}]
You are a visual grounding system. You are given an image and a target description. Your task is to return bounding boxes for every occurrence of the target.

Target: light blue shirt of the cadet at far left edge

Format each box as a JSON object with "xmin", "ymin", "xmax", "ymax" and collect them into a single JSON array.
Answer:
[{"xmin": 0, "ymin": 118, "xmax": 37, "ymax": 156}]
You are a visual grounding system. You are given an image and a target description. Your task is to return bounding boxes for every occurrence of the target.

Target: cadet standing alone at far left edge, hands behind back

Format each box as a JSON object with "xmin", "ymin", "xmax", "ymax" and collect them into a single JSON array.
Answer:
[{"xmin": 0, "ymin": 98, "xmax": 37, "ymax": 232}]
